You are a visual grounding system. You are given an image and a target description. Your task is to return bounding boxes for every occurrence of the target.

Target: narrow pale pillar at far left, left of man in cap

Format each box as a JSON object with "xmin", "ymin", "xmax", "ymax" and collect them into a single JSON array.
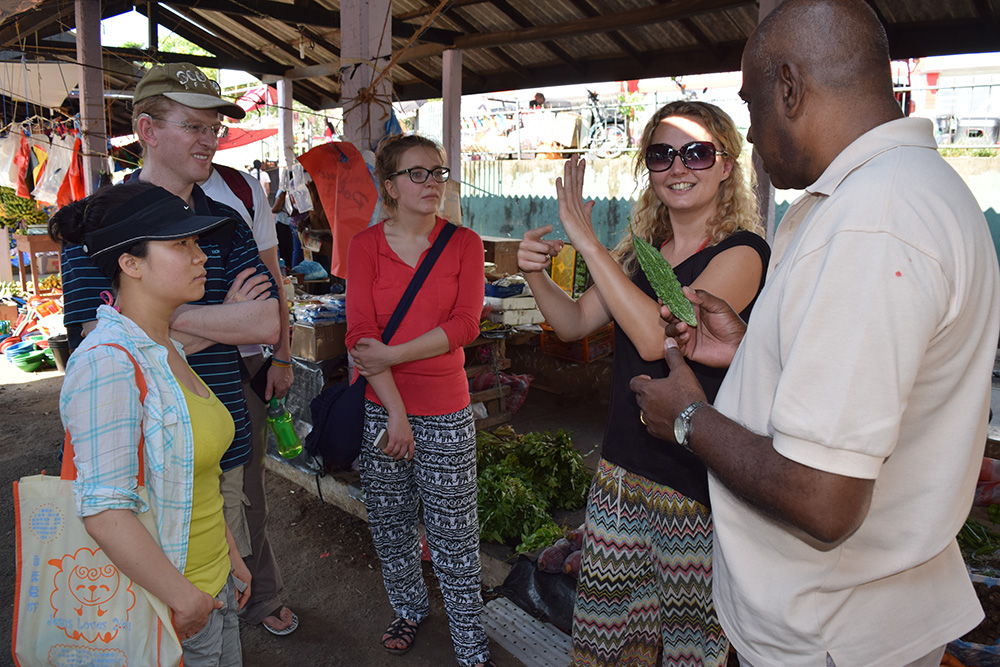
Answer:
[{"xmin": 75, "ymin": 0, "xmax": 108, "ymax": 194}]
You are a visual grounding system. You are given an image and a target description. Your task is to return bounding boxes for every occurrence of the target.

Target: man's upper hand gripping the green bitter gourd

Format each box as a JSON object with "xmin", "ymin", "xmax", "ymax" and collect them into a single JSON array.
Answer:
[{"xmin": 660, "ymin": 287, "xmax": 747, "ymax": 368}]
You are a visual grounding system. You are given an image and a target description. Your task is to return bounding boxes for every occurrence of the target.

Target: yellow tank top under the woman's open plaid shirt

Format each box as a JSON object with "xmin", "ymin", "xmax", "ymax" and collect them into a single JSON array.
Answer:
[{"xmin": 179, "ymin": 377, "xmax": 236, "ymax": 597}]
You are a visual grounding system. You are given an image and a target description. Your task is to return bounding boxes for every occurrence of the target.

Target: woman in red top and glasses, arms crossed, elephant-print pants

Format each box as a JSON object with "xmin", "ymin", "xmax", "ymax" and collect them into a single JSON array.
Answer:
[{"xmin": 347, "ymin": 134, "xmax": 491, "ymax": 666}]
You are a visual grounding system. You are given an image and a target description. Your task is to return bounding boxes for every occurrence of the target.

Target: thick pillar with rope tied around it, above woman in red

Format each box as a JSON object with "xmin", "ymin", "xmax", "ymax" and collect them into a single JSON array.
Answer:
[{"xmin": 340, "ymin": 0, "xmax": 392, "ymax": 150}]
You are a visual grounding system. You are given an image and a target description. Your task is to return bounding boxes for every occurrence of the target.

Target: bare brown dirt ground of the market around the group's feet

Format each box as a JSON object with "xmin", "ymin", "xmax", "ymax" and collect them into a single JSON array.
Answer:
[{"xmin": 0, "ymin": 360, "xmax": 600, "ymax": 667}]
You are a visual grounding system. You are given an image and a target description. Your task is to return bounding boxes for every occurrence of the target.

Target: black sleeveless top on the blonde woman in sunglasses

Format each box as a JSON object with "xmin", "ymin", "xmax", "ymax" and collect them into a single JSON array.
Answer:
[{"xmin": 601, "ymin": 231, "xmax": 771, "ymax": 507}]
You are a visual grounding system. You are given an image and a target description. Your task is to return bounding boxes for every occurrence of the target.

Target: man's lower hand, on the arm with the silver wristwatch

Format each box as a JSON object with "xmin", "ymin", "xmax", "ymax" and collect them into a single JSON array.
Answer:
[{"xmin": 629, "ymin": 338, "xmax": 706, "ymax": 442}]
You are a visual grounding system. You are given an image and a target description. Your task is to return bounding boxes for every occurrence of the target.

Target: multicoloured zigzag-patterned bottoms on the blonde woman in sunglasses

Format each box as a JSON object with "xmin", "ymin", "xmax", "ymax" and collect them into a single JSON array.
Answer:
[{"xmin": 573, "ymin": 459, "xmax": 729, "ymax": 667}]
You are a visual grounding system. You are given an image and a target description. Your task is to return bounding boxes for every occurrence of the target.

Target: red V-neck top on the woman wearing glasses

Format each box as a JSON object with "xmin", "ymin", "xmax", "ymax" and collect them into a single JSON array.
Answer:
[{"xmin": 346, "ymin": 218, "xmax": 484, "ymax": 415}]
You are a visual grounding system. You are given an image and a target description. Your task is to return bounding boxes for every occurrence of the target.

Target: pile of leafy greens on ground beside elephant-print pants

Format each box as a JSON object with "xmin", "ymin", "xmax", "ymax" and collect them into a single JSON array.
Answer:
[{"xmin": 476, "ymin": 427, "xmax": 591, "ymax": 553}]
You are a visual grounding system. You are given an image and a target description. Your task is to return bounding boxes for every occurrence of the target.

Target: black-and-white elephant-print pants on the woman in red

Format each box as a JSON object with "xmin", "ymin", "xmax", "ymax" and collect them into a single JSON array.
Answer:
[{"xmin": 361, "ymin": 400, "xmax": 490, "ymax": 665}]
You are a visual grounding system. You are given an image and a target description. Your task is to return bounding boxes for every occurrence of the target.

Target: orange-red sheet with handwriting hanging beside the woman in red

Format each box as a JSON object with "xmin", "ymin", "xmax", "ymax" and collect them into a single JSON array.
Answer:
[{"xmin": 299, "ymin": 141, "xmax": 378, "ymax": 278}]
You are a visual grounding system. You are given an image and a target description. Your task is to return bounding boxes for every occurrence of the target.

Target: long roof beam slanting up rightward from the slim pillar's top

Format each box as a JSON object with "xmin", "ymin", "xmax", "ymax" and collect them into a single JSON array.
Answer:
[{"xmin": 455, "ymin": 0, "xmax": 756, "ymax": 49}]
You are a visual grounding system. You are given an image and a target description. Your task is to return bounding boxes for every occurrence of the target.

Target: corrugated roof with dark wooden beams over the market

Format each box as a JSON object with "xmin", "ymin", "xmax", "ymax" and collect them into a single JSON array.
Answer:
[{"xmin": 0, "ymin": 0, "xmax": 1000, "ymax": 120}]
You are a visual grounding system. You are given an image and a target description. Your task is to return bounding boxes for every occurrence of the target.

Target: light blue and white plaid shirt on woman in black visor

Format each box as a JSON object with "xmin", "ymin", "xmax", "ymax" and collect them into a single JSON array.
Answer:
[{"xmin": 59, "ymin": 306, "xmax": 220, "ymax": 572}]
